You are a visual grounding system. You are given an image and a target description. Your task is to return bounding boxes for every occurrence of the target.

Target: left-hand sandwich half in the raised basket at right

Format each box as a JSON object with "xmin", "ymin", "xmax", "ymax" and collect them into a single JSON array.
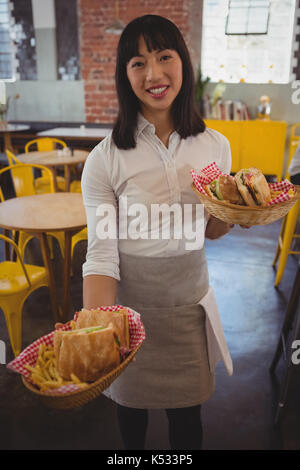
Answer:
[{"xmin": 204, "ymin": 175, "xmax": 245, "ymax": 205}]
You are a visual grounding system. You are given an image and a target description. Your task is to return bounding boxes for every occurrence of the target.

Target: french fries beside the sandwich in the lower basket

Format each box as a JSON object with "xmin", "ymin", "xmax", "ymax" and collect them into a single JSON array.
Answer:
[{"xmin": 24, "ymin": 344, "xmax": 88, "ymax": 392}]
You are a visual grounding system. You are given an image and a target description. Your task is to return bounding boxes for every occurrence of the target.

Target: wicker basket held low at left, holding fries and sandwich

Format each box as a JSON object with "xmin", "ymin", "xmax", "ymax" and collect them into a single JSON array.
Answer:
[{"xmin": 22, "ymin": 343, "xmax": 142, "ymax": 410}]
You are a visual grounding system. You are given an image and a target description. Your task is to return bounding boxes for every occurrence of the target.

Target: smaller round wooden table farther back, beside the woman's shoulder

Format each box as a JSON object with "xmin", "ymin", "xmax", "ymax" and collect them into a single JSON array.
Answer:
[{"xmin": 17, "ymin": 149, "xmax": 89, "ymax": 191}]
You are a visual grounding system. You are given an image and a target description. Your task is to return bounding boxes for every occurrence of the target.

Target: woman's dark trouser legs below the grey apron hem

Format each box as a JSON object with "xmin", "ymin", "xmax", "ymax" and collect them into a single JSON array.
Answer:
[{"xmin": 117, "ymin": 405, "xmax": 203, "ymax": 450}]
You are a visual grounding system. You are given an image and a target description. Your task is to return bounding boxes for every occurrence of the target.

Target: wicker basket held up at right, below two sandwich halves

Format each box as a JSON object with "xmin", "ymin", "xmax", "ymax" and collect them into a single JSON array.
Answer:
[{"xmin": 192, "ymin": 183, "xmax": 300, "ymax": 226}]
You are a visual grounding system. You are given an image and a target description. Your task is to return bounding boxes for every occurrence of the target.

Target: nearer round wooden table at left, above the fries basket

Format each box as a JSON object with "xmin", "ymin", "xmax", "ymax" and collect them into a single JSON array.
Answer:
[{"xmin": 0, "ymin": 193, "xmax": 86, "ymax": 321}]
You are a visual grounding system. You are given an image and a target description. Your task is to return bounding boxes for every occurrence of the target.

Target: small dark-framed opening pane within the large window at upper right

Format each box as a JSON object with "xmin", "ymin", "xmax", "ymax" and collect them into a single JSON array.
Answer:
[{"xmin": 226, "ymin": 0, "xmax": 270, "ymax": 34}]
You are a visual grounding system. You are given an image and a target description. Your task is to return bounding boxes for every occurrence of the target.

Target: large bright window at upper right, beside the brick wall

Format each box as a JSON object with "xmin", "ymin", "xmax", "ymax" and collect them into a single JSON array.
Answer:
[{"xmin": 201, "ymin": 0, "xmax": 298, "ymax": 83}]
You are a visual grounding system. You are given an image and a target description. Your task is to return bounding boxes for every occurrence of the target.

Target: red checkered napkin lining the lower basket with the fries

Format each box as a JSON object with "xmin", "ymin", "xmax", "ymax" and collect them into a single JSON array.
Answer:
[{"xmin": 6, "ymin": 305, "xmax": 146, "ymax": 394}]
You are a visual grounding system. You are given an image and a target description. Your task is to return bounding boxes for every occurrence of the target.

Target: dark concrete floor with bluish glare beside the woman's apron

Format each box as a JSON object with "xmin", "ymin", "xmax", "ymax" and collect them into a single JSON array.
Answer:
[{"xmin": 0, "ymin": 222, "xmax": 300, "ymax": 450}]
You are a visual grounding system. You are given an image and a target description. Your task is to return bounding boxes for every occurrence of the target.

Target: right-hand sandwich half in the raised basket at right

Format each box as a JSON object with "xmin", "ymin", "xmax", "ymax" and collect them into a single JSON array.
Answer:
[{"xmin": 234, "ymin": 167, "xmax": 271, "ymax": 207}]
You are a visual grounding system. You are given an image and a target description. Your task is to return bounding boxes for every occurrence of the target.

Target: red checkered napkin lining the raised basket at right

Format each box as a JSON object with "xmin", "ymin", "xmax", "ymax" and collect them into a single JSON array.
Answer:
[{"xmin": 190, "ymin": 162, "xmax": 294, "ymax": 206}]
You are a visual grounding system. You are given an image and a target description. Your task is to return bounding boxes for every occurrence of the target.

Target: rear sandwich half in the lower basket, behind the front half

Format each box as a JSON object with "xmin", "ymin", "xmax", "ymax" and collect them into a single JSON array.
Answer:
[{"xmin": 75, "ymin": 308, "xmax": 130, "ymax": 348}]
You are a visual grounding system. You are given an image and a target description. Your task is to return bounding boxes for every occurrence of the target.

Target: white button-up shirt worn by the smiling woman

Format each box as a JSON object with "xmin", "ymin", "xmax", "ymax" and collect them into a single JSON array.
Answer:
[{"xmin": 82, "ymin": 114, "xmax": 231, "ymax": 280}]
